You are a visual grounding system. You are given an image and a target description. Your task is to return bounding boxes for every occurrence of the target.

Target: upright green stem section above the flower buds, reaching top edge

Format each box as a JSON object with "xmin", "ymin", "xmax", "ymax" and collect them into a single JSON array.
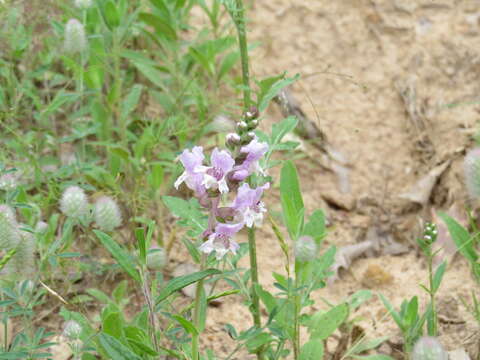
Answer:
[{"xmin": 233, "ymin": 0, "xmax": 251, "ymax": 111}]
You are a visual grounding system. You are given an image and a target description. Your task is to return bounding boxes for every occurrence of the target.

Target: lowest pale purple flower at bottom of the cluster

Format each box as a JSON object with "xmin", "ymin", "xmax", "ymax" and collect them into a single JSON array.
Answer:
[{"xmin": 200, "ymin": 223, "xmax": 243, "ymax": 259}]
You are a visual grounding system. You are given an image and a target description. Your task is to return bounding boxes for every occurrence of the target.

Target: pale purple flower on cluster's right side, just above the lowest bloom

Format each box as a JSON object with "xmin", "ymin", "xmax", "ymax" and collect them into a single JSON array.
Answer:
[{"xmin": 232, "ymin": 183, "xmax": 270, "ymax": 227}]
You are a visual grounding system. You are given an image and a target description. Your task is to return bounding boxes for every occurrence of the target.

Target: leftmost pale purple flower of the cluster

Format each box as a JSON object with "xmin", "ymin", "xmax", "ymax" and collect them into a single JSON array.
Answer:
[{"xmin": 174, "ymin": 146, "xmax": 205, "ymax": 195}]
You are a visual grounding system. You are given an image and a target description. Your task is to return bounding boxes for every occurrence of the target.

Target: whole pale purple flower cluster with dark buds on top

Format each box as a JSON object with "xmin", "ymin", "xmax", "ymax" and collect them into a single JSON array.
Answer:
[{"xmin": 175, "ymin": 107, "xmax": 270, "ymax": 259}]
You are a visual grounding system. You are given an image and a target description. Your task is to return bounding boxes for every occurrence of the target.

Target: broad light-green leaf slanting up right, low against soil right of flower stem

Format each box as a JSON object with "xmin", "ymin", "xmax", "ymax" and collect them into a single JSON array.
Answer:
[{"xmin": 307, "ymin": 304, "xmax": 348, "ymax": 340}]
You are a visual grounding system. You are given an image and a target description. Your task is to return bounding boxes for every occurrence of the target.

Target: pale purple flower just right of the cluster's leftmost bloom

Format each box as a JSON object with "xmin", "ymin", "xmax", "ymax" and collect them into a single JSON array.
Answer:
[{"xmin": 195, "ymin": 148, "xmax": 235, "ymax": 194}]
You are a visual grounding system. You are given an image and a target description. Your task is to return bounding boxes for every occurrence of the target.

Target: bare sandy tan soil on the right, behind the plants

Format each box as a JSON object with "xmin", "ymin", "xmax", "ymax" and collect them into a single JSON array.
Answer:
[{"xmin": 177, "ymin": 0, "xmax": 480, "ymax": 359}]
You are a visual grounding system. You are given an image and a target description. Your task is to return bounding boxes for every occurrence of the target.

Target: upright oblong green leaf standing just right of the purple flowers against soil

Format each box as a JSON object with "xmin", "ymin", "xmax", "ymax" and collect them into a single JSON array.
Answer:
[{"xmin": 280, "ymin": 161, "xmax": 304, "ymax": 240}]
